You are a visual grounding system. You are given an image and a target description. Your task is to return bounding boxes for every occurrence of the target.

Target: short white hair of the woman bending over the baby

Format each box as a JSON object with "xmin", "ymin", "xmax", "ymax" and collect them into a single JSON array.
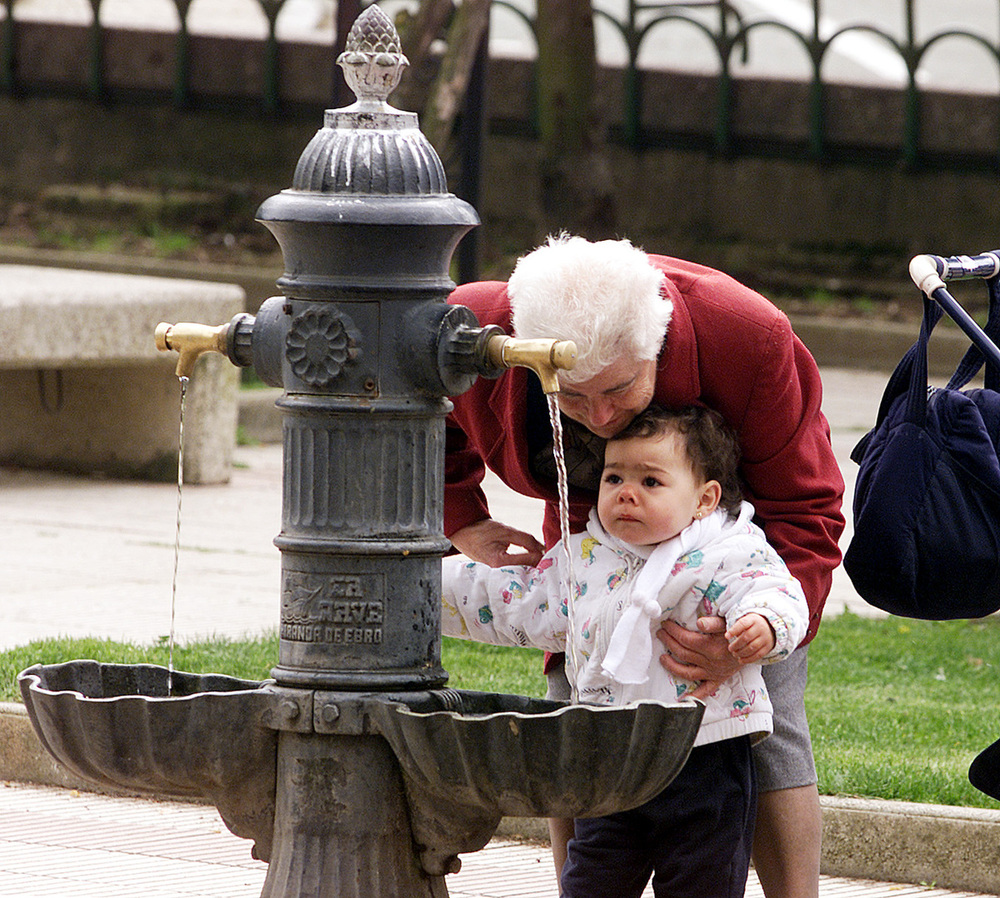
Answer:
[{"xmin": 507, "ymin": 234, "xmax": 673, "ymax": 383}]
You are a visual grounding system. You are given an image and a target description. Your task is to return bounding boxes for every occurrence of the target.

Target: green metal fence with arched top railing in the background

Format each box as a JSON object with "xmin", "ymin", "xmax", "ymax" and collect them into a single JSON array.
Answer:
[{"xmin": 0, "ymin": 0, "xmax": 1000, "ymax": 166}]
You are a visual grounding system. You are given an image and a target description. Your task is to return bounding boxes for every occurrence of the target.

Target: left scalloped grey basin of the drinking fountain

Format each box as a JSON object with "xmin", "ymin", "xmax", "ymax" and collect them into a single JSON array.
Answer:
[{"xmin": 18, "ymin": 660, "xmax": 277, "ymax": 860}]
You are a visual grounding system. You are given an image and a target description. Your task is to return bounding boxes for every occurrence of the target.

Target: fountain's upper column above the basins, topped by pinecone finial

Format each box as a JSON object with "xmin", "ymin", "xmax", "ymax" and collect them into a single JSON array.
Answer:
[{"xmin": 252, "ymin": 7, "xmax": 479, "ymax": 691}]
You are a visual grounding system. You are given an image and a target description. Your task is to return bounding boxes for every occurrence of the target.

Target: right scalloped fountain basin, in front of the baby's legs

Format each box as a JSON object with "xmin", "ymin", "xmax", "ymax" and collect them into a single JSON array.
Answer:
[{"xmin": 378, "ymin": 691, "xmax": 704, "ymax": 817}]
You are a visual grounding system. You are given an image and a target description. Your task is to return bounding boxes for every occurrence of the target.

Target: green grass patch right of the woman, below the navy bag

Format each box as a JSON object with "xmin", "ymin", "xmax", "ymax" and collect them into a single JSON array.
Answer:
[{"xmin": 806, "ymin": 615, "xmax": 1000, "ymax": 808}]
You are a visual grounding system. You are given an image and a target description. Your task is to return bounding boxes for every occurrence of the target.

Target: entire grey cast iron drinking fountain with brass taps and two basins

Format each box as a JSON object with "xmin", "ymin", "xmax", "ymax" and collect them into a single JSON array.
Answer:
[{"xmin": 19, "ymin": 6, "xmax": 703, "ymax": 898}]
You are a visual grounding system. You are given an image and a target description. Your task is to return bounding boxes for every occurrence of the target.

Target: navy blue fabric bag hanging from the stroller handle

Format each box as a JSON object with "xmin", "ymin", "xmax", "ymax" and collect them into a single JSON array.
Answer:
[{"xmin": 844, "ymin": 278, "xmax": 1000, "ymax": 620}]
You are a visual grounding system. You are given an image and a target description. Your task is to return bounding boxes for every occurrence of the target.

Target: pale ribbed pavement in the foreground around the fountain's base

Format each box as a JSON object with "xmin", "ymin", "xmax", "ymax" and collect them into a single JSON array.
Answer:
[{"xmin": 0, "ymin": 783, "xmax": 986, "ymax": 898}]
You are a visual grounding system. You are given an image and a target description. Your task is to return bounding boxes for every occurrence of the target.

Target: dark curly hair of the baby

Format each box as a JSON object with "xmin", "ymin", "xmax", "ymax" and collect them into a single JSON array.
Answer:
[{"xmin": 608, "ymin": 405, "xmax": 743, "ymax": 517}]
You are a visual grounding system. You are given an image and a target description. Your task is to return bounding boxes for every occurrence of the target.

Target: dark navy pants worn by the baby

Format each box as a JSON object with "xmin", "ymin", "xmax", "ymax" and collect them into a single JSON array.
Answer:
[{"xmin": 560, "ymin": 736, "xmax": 757, "ymax": 898}]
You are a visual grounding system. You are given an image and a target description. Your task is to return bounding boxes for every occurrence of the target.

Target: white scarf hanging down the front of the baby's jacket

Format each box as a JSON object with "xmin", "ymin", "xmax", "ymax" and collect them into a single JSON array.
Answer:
[{"xmin": 601, "ymin": 509, "xmax": 728, "ymax": 683}]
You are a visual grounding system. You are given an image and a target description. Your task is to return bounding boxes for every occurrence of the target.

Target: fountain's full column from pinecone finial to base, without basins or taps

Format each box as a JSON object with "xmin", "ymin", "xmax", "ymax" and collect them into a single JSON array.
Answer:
[{"xmin": 247, "ymin": 6, "xmax": 479, "ymax": 898}]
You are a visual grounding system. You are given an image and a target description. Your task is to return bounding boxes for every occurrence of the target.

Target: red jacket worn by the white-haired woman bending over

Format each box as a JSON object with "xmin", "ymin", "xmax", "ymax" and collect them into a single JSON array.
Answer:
[{"xmin": 445, "ymin": 256, "xmax": 844, "ymax": 644}]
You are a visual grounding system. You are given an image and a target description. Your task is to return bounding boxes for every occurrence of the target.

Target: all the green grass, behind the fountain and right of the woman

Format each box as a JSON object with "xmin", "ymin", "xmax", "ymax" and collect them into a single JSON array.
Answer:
[{"xmin": 0, "ymin": 614, "xmax": 1000, "ymax": 809}]
